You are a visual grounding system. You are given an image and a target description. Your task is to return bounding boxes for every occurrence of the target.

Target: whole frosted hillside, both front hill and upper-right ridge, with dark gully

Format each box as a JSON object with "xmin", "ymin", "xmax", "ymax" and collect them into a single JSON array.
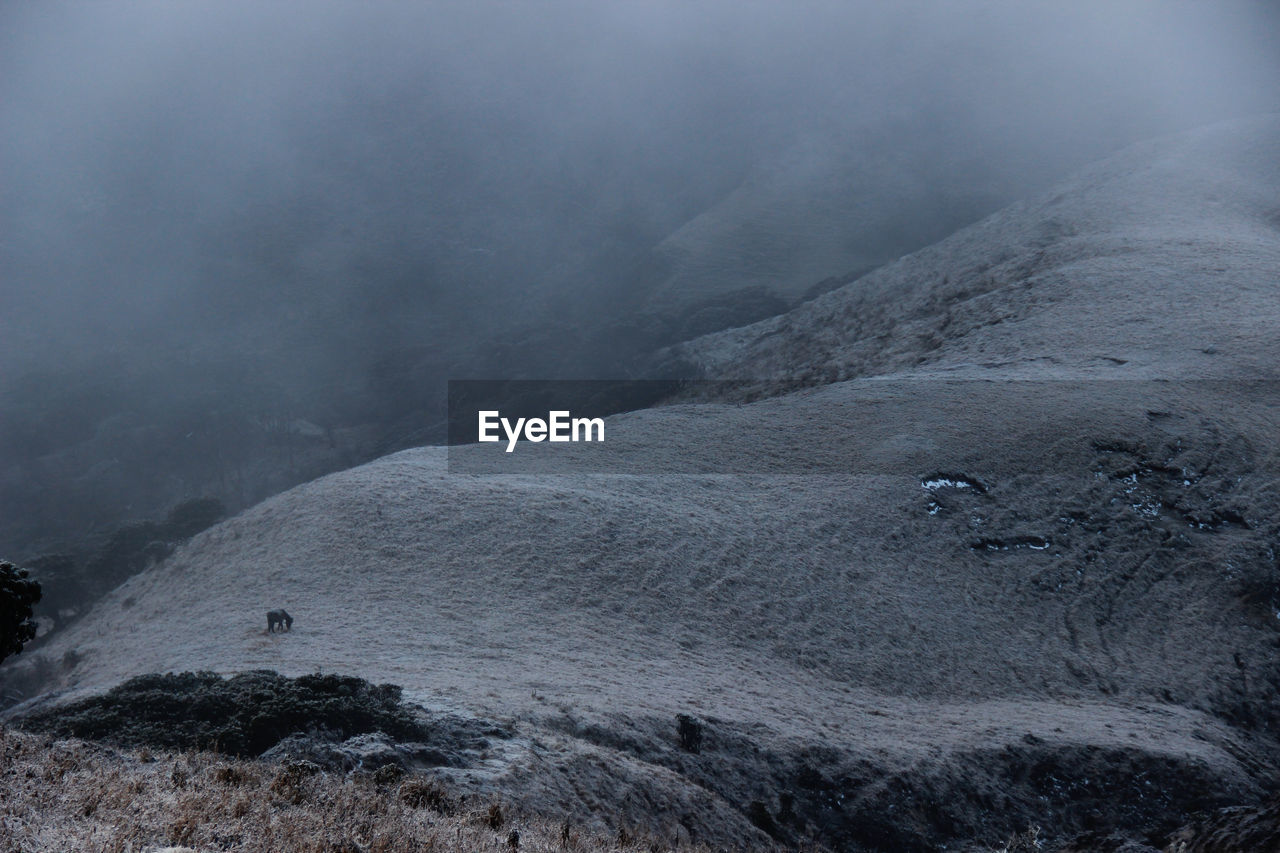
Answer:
[{"xmin": 10, "ymin": 119, "xmax": 1280, "ymax": 850}]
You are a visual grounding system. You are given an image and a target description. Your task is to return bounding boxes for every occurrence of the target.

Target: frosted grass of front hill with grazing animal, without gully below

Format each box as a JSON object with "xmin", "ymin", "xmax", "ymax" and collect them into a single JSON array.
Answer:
[{"xmin": 30, "ymin": 383, "xmax": 1276, "ymax": 712}]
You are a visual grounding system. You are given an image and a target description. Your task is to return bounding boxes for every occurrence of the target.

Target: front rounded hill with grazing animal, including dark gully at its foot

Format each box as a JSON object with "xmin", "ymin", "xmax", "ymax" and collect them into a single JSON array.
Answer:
[{"xmin": 17, "ymin": 383, "xmax": 1280, "ymax": 849}]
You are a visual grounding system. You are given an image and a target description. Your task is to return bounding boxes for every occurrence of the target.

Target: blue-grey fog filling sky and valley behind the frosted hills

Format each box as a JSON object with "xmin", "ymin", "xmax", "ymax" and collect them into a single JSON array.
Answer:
[{"xmin": 0, "ymin": 0, "xmax": 1280, "ymax": 551}]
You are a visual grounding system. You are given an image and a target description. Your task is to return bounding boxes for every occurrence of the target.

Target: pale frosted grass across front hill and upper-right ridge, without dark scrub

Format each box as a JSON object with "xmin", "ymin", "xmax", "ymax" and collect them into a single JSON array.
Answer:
[{"xmin": 10, "ymin": 119, "xmax": 1280, "ymax": 845}]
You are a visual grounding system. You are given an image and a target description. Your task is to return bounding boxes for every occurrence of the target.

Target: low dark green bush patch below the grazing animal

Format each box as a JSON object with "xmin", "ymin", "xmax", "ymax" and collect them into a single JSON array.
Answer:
[{"xmin": 19, "ymin": 670, "xmax": 429, "ymax": 756}]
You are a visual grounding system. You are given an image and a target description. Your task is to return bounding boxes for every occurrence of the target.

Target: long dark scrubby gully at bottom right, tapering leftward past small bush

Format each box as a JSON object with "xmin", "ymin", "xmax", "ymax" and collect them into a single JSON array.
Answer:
[{"xmin": 537, "ymin": 716, "xmax": 1271, "ymax": 853}]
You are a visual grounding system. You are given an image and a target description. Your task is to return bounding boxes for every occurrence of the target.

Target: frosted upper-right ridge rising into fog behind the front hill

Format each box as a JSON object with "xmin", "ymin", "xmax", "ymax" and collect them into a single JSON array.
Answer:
[{"xmin": 676, "ymin": 117, "xmax": 1280, "ymax": 383}]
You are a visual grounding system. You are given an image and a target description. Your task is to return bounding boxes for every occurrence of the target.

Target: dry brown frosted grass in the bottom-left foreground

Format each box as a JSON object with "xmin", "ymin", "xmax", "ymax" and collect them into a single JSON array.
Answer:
[{"xmin": 0, "ymin": 727, "xmax": 721, "ymax": 853}]
